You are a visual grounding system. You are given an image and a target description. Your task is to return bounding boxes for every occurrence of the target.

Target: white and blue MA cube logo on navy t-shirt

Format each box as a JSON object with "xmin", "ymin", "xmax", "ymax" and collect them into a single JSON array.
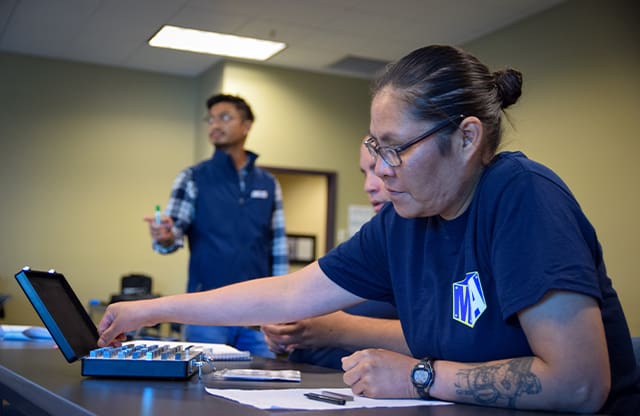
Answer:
[{"xmin": 453, "ymin": 272, "xmax": 487, "ymax": 328}]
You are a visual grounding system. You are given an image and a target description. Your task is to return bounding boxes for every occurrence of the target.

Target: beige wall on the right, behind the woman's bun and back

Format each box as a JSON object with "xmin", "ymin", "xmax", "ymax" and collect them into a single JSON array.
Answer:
[{"xmin": 465, "ymin": 0, "xmax": 640, "ymax": 336}]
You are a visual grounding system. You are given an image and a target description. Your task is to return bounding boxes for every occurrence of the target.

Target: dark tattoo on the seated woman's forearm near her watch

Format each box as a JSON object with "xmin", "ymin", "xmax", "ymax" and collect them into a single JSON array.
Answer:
[{"xmin": 455, "ymin": 357, "xmax": 542, "ymax": 408}]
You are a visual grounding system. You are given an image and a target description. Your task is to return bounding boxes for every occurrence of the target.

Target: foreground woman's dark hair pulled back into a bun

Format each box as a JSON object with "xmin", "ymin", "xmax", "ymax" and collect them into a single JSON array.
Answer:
[{"xmin": 372, "ymin": 45, "xmax": 522, "ymax": 152}]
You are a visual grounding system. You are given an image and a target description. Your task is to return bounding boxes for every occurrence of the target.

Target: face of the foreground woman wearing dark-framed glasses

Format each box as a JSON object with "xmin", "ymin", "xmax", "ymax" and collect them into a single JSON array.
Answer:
[{"xmin": 369, "ymin": 87, "xmax": 475, "ymax": 219}]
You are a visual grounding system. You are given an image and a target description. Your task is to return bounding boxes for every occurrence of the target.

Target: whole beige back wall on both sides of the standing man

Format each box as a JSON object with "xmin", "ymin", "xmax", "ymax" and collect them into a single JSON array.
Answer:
[{"xmin": 0, "ymin": 54, "xmax": 368, "ymax": 323}]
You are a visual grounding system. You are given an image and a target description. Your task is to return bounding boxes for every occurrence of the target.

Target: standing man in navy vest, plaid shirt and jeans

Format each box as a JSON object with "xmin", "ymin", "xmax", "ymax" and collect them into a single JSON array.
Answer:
[{"xmin": 145, "ymin": 94, "xmax": 288, "ymax": 357}]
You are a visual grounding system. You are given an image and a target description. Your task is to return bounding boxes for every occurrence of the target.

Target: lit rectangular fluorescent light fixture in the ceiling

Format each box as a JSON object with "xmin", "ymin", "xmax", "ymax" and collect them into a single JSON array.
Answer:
[{"xmin": 149, "ymin": 25, "xmax": 287, "ymax": 61}]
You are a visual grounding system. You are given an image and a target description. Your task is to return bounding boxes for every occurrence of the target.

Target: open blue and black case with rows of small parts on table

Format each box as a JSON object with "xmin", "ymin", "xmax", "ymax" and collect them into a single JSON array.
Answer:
[{"xmin": 16, "ymin": 267, "xmax": 205, "ymax": 379}]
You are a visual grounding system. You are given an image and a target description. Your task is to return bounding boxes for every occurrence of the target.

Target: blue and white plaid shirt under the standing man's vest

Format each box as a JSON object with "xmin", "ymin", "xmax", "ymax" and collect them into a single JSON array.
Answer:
[{"xmin": 153, "ymin": 162, "xmax": 289, "ymax": 276}]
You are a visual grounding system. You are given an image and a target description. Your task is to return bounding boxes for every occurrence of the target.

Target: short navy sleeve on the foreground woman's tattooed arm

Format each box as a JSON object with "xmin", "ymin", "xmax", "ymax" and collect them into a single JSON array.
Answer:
[{"xmin": 485, "ymin": 169, "xmax": 601, "ymax": 319}]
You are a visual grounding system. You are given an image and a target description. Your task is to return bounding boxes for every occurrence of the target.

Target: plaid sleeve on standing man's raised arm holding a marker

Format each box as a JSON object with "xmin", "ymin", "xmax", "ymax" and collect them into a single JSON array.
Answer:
[{"xmin": 152, "ymin": 168, "xmax": 198, "ymax": 254}]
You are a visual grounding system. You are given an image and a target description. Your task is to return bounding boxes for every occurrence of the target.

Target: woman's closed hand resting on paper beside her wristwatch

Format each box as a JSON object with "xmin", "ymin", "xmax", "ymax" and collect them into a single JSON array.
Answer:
[{"xmin": 342, "ymin": 349, "xmax": 419, "ymax": 399}]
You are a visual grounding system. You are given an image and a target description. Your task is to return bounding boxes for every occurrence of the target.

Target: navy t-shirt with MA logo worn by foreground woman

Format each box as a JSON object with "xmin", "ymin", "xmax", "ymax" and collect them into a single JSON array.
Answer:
[{"xmin": 319, "ymin": 152, "xmax": 640, "ymax": 412}]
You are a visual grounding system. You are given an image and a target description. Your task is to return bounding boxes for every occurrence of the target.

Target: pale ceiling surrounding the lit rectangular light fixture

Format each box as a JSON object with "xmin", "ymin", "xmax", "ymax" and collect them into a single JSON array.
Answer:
[{"xmin": 0, "ymin": 0, "xmax": 565, "ymax": 76}]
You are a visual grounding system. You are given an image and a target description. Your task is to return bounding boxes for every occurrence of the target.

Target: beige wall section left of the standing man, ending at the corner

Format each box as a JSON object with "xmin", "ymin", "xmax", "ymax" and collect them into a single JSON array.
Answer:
[{"xmin": 0, "ymin": 54, "xmax": 196, "ymax": 323}]
